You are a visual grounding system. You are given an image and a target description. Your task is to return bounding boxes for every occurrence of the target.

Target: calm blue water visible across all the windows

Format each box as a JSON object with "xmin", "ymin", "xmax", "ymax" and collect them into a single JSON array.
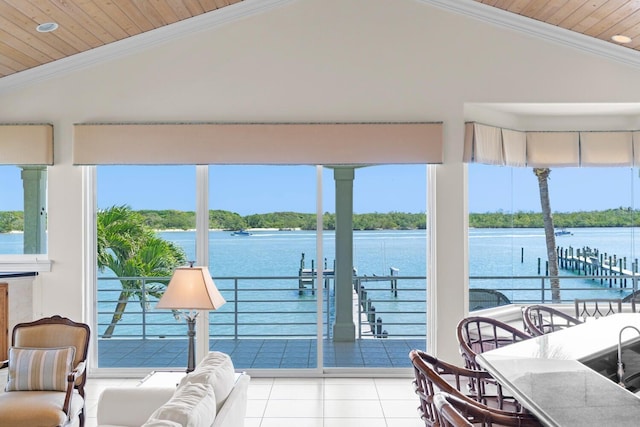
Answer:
[{"xmin": 8, "ymin": 228, "xmax": 640, "ymax": 336}]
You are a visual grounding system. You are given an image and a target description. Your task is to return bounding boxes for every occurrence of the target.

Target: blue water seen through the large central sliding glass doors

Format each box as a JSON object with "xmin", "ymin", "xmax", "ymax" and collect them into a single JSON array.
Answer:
[{"xmin": 98, "ymin": 230, "xmax": 426, "ymax": 337}]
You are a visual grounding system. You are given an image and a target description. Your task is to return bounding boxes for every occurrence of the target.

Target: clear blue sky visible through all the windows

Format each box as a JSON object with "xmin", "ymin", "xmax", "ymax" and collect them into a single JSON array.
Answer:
[{"xmin": 0, "ymin": 165, "xmax": 640, "ymax": 215}]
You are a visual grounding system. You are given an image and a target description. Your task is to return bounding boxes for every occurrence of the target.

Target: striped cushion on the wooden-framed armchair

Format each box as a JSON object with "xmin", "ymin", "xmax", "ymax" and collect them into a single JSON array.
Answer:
[{"xmin": 5, "ymin": 347, "xmax": 76, "ymax": 391}]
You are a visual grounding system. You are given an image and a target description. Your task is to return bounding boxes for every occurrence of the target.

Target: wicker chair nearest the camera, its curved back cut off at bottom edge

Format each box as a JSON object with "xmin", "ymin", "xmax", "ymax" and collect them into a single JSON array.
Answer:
[{"xmin": 433, "ymin": 392, "xmax": 542, "ymax": 427}]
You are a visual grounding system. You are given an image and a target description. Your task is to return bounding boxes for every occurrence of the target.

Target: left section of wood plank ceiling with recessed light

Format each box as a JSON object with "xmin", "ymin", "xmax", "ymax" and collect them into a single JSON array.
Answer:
[{"xmin": 0, "ymin": 0, "xmax": 242, "ymax": 78}]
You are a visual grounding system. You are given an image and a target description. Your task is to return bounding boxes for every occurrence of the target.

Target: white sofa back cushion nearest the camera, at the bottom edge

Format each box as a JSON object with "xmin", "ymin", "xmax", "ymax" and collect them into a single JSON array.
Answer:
[{"xmin": 147, "ymin": 383, "xmax": 216, "ymax": 427}]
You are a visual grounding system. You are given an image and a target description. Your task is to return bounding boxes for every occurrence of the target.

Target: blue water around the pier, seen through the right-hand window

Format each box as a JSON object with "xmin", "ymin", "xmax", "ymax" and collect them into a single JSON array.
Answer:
[{"xmin": 469, "ymin": 227, "xmax": 640, "ymax": 303}]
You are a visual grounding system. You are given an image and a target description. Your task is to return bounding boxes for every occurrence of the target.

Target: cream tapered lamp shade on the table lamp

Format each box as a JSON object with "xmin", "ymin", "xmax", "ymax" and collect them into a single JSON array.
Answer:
[{"xmin": 156, "ymin": 267, "xmax": 226, "ymax": 310}]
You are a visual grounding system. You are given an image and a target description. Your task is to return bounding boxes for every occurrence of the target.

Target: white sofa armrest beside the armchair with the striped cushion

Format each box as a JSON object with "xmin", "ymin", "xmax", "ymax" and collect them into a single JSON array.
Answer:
[{"xmin": 97, "ymin": 387, "xmax": 176, "ymax": 427}]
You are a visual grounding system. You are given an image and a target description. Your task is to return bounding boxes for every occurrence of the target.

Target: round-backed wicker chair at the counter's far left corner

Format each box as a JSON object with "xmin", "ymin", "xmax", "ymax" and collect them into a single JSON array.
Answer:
[{"xmin": 456, "ymin": 316, "xmax": 532, "ymax": 370}]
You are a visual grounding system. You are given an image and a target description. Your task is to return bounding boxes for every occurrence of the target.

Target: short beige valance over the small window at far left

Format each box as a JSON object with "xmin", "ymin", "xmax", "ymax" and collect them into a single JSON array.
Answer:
[{"xmin": 0, "ymin": 124, "xmax": 53, "ymax": 165}]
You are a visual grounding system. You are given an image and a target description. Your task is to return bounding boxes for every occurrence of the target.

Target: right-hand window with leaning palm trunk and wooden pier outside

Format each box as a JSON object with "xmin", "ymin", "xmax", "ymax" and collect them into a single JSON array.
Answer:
[{"xmin": 469, "ymin": 164, "xmax": 640, "ymax": 310}]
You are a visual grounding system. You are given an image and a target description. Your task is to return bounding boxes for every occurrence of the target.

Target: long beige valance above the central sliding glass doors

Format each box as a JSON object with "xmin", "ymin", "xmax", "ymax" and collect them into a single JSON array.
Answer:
[{"xmin": 73, "ymin": 123, "xmax": 443, "ymax": 165}]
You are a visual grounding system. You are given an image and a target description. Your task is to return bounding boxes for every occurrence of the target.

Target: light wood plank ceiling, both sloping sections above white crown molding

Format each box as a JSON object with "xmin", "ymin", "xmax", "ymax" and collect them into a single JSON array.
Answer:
[{"xmin": 0, "ymin": 0, "xmax": 640, "ymax": 84}]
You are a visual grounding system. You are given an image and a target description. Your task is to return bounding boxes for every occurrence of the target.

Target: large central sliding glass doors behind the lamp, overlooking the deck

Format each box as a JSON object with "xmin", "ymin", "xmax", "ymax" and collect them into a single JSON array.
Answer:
[{"xmin": 96, "ymin": 165, "xmax": 427, "ymax": 369}]
